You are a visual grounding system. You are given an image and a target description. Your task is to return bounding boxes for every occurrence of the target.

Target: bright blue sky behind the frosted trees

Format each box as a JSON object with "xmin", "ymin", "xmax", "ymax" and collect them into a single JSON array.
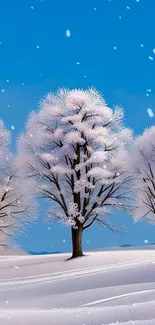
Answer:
[{"xmin": 0, "ymin": 0, "xmax": 155, "ymax": 251}]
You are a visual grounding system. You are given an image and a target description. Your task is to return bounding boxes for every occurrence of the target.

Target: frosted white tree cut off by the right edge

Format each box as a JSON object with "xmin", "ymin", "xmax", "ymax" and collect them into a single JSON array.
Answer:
[{"xmin": 130, "ymin": 126, "xmax": 155, "ymax": 223}]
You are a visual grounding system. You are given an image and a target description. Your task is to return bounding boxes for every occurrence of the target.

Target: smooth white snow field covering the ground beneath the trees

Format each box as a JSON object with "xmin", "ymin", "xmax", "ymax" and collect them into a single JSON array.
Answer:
[{"xmin": 0, "ymin": 249, "xmax": 155, "ymax": 325}]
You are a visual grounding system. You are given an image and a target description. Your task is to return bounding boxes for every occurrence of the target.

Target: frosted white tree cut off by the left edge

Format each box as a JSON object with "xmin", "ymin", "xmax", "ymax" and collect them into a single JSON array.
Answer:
[{"xmin": 0, "ymin": 121, "xmax": 35, "ymax": 245}]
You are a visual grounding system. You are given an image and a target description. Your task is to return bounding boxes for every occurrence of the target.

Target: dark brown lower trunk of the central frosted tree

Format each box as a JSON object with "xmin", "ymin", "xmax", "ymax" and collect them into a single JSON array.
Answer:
[{"xmin": 72, "ymin": 225, "xmax": 83, "ymax": 258}]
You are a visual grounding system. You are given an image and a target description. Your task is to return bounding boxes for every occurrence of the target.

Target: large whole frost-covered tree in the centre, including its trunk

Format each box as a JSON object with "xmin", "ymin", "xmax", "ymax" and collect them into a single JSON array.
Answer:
[{"xmin": 18, "ymin": 89, "xmax": 132, "ymax": 257}]
